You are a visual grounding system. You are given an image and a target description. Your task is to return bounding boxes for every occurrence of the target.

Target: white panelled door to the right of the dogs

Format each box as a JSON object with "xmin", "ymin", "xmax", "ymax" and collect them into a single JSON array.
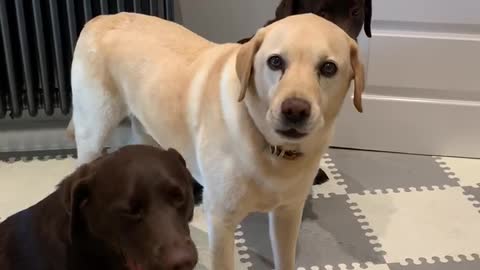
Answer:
[{"xmin": 334, "ymin": 0, "xmax": 480, "ymax": 158}]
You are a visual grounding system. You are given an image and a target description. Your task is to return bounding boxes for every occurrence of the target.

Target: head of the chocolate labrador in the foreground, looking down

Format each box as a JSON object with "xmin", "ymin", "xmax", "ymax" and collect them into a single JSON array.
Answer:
[{"xmin": 60, "ymin": 146, "xmax": 197, "ymax": 270}]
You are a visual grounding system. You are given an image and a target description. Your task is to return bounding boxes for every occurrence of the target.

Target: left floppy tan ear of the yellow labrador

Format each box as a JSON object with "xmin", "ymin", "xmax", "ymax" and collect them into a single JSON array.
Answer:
[{"xmin": 235, "ymin": 28, "xmax": 265, "ymax": 102}]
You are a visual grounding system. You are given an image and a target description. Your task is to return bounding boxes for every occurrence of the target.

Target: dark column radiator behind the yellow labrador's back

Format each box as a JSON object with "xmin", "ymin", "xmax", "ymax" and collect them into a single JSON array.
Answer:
[{"xmin": 0, "ymin": 0, "xmax": 174, "ymax": 119}]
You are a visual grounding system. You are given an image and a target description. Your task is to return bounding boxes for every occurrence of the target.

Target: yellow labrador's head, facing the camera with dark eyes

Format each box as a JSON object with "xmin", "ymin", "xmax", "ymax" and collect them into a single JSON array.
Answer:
[{"xmin": 236, "ymin": 14, "xmax": 364, "ymax": 149}]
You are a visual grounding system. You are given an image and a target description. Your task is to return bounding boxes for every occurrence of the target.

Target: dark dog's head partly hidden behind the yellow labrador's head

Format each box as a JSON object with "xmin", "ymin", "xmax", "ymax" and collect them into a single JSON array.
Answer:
[{"xmin": 269, "ymin": 0, "xmax": 372, "ymax": 39}]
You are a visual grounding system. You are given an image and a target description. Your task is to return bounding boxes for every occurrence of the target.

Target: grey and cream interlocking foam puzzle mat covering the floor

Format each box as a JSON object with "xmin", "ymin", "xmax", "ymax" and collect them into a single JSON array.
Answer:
[{"xmin": 0, "ymin": 149, "xmax": 480, "ymax": 270}]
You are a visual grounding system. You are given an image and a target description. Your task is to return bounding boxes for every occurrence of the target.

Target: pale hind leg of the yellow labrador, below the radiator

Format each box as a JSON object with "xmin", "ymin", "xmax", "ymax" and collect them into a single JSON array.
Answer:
[{"xmin": 72, "ymin": 81, "xmax": 127, "ymax": 166}]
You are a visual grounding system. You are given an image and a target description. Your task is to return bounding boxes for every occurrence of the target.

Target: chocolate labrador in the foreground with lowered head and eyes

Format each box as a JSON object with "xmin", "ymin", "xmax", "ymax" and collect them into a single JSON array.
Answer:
[{"xmin": 0, "ymin": 145, "xmax": 197, "ymax": 270}]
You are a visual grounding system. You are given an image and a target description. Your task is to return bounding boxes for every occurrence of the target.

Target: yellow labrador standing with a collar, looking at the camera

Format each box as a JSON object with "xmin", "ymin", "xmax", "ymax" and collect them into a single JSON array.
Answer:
[{"xmin": 69, "ymin": 13, "xmax": 364, "ymax": 270}]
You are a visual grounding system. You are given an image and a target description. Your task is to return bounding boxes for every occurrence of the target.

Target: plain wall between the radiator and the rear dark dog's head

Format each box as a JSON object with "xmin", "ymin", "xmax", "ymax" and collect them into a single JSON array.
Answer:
[{"xmin": 176, "ymin": 0, "xmax": 280, "ymax": 42}]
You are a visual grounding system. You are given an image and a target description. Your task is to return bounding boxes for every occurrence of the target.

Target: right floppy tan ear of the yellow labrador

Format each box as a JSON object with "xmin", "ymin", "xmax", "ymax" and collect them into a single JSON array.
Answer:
[{"xmin": 350, "ymin": 40, "xmax": 365, "ymax": 112}]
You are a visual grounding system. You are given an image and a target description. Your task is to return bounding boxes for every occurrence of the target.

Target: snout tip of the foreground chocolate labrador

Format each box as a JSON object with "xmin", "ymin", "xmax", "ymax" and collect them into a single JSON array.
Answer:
[{"xmin": 165, "ymin": 244, "xmax": 198, "ymax": 270}]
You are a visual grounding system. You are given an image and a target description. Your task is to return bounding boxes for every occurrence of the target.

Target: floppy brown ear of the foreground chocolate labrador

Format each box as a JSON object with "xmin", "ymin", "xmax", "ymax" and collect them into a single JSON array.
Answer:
[{"xmin": 59, "ymin": 164, "xmax": 94, "ymax": 243}]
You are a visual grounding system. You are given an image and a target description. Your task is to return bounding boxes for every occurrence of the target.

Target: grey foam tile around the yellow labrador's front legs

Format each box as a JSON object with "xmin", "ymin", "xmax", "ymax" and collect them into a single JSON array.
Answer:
[{"xmin": 242, "ymin": 195, "xmax": 385, "ymax": 270}]
